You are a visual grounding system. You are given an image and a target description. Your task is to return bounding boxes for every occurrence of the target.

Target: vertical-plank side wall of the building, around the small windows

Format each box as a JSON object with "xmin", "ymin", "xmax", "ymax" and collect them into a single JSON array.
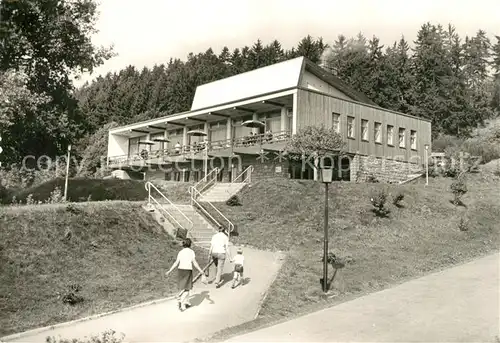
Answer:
[{"xmin": 296, "ymin": 88, "xmax": 431, "ymax": 163}]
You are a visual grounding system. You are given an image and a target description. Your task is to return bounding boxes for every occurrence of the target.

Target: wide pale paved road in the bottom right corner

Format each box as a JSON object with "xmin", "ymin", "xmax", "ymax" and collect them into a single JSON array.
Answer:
[{"xmin": 229, "ymin": 253, "xmax": 500, "ymax": 342}]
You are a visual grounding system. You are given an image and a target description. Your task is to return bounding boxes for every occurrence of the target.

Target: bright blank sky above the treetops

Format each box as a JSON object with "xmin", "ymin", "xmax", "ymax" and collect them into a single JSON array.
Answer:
[{"xmin": 77, "ymin": 0, "xmax": 500, "ymax": 84}]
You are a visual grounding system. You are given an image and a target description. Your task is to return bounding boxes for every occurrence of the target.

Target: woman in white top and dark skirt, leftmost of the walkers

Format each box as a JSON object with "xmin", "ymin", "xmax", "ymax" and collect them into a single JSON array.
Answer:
[{"xmin": 165, "ymin": 238, "xmax": 206, "ymax": 311}]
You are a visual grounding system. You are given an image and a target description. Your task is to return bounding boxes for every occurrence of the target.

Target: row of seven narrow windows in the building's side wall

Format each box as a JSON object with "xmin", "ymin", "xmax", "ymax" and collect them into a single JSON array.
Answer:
[{"xmin": 333, "ymin": 113, "xmax": 417, "ymax": 150}]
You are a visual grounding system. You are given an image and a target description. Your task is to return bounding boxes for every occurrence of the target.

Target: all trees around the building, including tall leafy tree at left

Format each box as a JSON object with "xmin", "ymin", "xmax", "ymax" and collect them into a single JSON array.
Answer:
[{"xmin": 0, "ymin": 0, "xmax": 500, "ymax": 183}]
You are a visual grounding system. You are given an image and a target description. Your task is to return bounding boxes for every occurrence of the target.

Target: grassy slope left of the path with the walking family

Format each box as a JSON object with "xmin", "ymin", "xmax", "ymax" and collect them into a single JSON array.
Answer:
[{"xmin": 0, "ymin": 202, "xmax": 206, "ymax": 336}]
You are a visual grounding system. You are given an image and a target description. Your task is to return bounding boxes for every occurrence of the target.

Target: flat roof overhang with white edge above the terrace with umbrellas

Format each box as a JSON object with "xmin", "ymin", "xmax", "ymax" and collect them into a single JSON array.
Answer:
[{"xmin": 109, "ymin": 92, "xmax": 296, "ymax": 138}]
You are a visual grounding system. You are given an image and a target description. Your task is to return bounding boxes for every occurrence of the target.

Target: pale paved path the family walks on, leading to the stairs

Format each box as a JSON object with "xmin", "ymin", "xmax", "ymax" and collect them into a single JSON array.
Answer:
[{"xmin": 4, "ymin": 247, "xmax": 282, "ymax": 343}]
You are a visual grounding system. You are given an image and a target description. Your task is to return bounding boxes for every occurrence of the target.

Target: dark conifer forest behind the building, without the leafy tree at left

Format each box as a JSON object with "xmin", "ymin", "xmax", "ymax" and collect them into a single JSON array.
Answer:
[{"xmin": 77, "ymin": 24, "xmax": 500, "ymax": 135}]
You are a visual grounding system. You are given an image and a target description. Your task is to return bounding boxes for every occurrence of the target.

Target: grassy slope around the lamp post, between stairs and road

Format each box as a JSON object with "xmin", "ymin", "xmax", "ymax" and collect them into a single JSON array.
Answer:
[{"xmin": 204, "ymin": 175, "xmax": 500, "ymax": 340}]
